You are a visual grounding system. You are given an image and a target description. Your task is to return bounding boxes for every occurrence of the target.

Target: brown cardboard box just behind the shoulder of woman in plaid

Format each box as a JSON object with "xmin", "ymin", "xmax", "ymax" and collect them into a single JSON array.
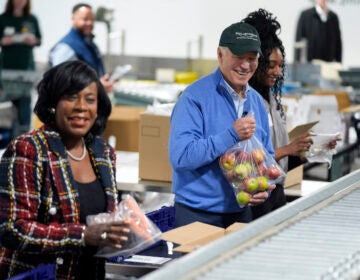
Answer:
[{"xmin": 102, "ymin": 106, "xmax": 146, "ymax": 152}]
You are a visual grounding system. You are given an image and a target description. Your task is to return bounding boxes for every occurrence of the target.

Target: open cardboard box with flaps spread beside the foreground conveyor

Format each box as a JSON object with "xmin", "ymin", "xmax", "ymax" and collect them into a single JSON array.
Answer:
[{"xmin": 163, "ymin": 222, "xmax": 247, "ymax": 253}]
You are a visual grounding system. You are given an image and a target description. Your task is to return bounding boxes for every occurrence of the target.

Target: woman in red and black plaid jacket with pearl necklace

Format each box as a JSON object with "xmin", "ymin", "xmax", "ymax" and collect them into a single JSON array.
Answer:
[{"xmin": 0, "ymin": 61, "xmax": 129, "ymax": 279}]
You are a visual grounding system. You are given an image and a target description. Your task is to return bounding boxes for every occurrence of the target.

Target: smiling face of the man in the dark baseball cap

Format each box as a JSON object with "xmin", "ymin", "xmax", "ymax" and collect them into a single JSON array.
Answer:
[{"xmin": 217, "ymin": 47, "xmax": 259, "ymax": 93}]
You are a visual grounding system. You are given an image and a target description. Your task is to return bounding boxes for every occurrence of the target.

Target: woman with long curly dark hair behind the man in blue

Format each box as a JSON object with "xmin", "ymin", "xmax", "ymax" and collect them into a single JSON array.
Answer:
[{"xmin": 243, "ymin": 9, "xmax": 312, "ymax": 219}]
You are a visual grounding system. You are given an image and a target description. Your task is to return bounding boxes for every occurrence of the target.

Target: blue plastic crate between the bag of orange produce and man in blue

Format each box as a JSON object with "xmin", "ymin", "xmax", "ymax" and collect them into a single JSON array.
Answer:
[{"xmin": 146, "ymin": 206, "xmax": 175, "ymax": 232}]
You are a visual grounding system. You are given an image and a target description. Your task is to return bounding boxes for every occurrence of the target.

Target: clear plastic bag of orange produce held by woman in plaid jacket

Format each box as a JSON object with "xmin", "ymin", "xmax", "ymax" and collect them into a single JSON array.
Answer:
[{"xmin": 86, "ymin": 195, "xmax": 162, "ymax": 258}]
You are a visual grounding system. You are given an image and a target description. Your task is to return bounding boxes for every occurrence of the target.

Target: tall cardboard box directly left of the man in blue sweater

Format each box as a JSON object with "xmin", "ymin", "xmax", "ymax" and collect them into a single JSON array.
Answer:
[{"xmin": 139, "ymin": 113, "xmax": 172, "ymax": 182}]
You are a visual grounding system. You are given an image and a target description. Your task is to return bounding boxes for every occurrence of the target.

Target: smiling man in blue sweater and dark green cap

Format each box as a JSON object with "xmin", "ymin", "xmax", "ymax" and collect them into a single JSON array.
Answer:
[{"xmin": 169, "ymin": 22, "xmax": 274, "ymax": 228}]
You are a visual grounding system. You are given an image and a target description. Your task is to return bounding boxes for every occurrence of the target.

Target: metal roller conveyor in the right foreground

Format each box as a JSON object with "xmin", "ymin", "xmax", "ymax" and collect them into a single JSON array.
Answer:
[{"xmin": 143, "ymin": 171, "xmax": 360, "ymax": 280}]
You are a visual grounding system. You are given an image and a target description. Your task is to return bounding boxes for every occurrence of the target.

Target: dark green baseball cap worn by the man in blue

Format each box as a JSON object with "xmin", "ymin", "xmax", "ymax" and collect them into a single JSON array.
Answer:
[{"xmin": 219, "ymin": 22, "xmax": 262, "ymax": 55}]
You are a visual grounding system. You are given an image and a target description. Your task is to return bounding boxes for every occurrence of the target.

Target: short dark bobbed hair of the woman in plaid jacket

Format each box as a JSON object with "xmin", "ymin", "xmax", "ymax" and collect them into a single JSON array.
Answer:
[{"xmin": 34, "ymin": 60, "xmax": 111, "ymax": 135}]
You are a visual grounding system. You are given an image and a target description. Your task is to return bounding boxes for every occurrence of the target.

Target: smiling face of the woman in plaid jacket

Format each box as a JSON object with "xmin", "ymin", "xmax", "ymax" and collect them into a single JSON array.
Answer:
[{"xmin": 55, "ymin": 82, "xmax": 98, "ymax": 139}]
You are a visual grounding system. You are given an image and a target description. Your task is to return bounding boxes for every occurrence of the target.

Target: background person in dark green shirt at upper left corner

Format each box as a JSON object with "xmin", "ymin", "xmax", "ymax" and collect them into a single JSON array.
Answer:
[{"xmin": 0, "ymin": 0, "xmax": 41, "ymax": 136}]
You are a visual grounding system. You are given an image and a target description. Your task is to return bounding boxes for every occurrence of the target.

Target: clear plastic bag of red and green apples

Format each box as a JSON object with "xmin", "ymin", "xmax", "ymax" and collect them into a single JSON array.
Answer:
[{"xmin": 219, "ymin": 136, "xmax": 285, "ymax": 207}]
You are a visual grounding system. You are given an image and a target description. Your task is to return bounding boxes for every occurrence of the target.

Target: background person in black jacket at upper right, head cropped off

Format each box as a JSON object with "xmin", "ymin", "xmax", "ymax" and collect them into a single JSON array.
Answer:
[{"xmin": 295, "ymin": 0, "xmax": 342, "ymax": 62}]
